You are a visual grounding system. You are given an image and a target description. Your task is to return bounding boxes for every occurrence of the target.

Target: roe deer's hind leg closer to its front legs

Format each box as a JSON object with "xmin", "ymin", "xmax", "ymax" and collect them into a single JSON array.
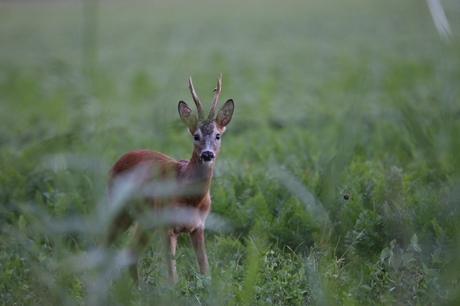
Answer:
[{"xmin": 128, "ymin": 223, "xmax": 151, "ymax": 285}]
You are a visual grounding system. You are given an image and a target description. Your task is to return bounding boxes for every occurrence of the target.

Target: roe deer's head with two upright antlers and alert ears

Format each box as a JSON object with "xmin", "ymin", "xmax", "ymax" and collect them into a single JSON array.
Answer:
[{"xmin": 178, "ymin": 74, "xmax": 235, "ymax": 164}]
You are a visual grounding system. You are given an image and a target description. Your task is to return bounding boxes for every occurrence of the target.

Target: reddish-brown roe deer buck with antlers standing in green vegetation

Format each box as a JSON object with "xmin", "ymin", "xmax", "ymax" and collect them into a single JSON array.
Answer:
[{"xmin": 106, "ymin": 74, "xmax": 234, "ymax": 285}]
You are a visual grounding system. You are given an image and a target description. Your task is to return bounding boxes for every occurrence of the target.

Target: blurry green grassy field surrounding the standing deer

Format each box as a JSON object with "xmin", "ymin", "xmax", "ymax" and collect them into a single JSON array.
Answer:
[{"xmin": 0, "ymin": 0, "xmax": 460, "ymax": 305}]
